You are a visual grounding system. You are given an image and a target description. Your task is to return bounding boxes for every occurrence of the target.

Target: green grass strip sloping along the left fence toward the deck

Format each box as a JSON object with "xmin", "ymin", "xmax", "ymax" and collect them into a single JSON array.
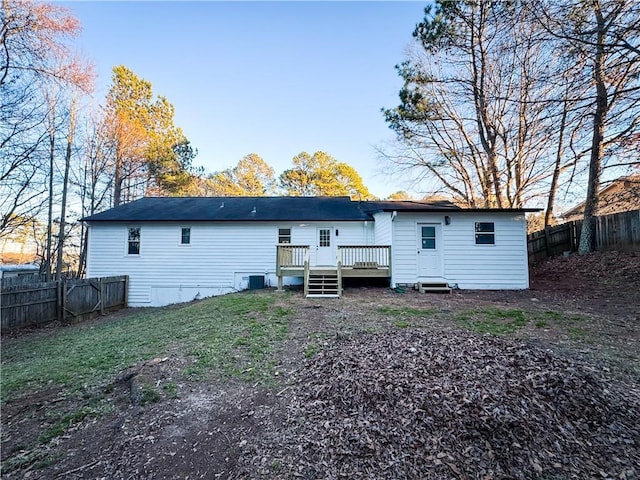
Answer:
[{"xmin": 2, "ymin": 292, "xmax": 290, "ymax": 401}]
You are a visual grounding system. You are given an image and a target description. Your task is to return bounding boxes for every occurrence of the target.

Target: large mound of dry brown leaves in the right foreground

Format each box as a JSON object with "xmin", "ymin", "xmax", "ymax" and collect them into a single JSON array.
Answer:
[{"xmin": 245, "ymin": 330, "xmax": 640, "ymax": 479}]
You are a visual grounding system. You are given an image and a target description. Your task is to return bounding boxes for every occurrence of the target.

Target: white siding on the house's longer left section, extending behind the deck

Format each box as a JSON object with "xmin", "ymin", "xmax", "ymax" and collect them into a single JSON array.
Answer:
[{"xmin": 87, "ymin": 222, "xmax": 365, "ymax": 306}]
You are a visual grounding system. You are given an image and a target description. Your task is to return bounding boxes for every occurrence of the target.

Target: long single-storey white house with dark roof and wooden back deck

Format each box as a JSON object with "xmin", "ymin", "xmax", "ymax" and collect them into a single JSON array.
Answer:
[{"xmin": 84, "ymin": 197, "xmax": 535, "ymax": 306}]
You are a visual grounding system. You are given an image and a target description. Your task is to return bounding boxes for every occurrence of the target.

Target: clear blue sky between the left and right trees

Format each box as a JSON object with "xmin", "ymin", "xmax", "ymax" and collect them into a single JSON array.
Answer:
[{"xmin": 60, "ymin": 1, "xmax": 426, "ymax": 197}]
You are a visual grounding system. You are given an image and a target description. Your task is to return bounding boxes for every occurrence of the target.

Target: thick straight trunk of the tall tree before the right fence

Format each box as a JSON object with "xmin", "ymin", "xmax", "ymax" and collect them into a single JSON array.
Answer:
[{"xmin": 578, "ymin": 2, "xmax": 609, "ymax": 255}]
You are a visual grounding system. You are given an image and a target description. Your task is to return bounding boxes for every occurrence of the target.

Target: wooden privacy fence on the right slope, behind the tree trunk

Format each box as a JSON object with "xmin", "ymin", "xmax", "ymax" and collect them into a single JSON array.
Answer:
[{"xmin": 527, "ymin": 210, "xmax": 640, "ymax": 263}]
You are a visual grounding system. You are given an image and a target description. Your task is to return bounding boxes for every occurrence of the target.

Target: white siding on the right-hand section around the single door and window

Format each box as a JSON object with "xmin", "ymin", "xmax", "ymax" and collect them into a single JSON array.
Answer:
[{"xmin": 393, "ymin": 212, "xmax": 529, "ymax": 290}]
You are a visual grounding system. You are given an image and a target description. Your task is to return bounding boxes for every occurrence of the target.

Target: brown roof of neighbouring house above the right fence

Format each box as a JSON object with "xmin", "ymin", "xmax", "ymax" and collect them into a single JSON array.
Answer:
[{"xmin": 561, "ymin": 175, "xmax": 640, "ymax": 221}]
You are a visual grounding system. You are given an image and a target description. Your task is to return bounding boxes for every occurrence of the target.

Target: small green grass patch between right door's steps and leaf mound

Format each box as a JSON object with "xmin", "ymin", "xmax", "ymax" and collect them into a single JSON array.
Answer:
[{"xmin": 455, "ymin": 308, "xmax": 529, "ymax": 336}]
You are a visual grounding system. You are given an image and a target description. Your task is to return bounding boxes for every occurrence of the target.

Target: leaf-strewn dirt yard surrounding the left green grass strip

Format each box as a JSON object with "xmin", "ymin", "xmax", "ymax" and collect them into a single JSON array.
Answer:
[{"xmin": 2, "ymin": 252, "xmax": 640, "ymax": 479}]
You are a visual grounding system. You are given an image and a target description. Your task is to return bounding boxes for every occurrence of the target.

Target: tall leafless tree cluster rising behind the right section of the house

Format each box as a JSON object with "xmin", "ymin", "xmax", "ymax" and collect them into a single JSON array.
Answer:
[{"xmin": 384, "ymin": 1, "xmax": 564, "ymax": 207}]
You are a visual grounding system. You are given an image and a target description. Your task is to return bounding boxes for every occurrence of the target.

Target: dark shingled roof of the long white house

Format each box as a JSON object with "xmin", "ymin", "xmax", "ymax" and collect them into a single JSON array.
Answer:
[{"xmin": 82, "ymin": 197, "xmax": 538, "ymax": 222}]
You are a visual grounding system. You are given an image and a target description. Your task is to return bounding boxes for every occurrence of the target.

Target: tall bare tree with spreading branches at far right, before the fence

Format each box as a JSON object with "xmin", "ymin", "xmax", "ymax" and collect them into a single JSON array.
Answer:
[{"xmin": 531, "ymin": 0, "xmax": 640, "ymax": 254}]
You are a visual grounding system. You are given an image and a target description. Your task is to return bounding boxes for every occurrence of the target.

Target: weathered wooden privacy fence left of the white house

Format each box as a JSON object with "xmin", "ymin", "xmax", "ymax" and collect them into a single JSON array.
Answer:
[{"xmin": 0, "ymin": 275, "xmax": 129, "ymax": 329}]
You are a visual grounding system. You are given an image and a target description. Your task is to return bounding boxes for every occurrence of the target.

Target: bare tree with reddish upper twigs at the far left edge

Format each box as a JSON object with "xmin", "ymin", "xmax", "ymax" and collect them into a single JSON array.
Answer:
[{"xmin": 0, "ymin": 0, "xmax": 93, "ymax": 240}]
